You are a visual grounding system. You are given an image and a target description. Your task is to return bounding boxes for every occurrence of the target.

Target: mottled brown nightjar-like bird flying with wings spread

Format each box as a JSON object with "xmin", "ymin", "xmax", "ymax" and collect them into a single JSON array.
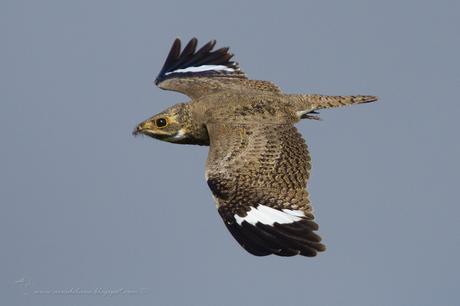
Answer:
[{"xmin": 133, "ymin": 38, "xmax": 377, "ymax": 257}]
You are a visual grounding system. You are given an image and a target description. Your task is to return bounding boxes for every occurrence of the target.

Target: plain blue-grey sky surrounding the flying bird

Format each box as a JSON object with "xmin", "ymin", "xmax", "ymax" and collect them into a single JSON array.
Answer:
[{"xmin": 0, "ymin": 0, "xmax": 460, "ymax": 306}]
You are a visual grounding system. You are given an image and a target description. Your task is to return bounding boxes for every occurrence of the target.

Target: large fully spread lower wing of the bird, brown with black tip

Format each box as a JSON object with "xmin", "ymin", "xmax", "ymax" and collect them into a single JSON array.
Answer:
[{"xmin": 206, "ymin": 123, "xmax": 325, "ymax": 256}]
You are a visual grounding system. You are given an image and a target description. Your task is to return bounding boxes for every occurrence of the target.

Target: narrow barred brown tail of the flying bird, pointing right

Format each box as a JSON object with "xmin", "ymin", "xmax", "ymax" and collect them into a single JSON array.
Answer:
[{"xmin": 288, "ymin": 95, "xmax": 378, "ymax": 119}]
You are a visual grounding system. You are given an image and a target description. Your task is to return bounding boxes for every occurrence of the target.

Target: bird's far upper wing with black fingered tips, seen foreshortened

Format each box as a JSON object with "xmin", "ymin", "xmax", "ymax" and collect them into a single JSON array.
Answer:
[{"xmin": 155, "ymin": 38, "xmax": 280, "ymax": 99}]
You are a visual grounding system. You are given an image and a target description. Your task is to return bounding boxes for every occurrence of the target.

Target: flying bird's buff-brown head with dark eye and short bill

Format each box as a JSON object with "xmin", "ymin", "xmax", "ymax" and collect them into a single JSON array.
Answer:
[{"xmin": 133, "ymin": 103, "xmax": 190, "ymax": 142}]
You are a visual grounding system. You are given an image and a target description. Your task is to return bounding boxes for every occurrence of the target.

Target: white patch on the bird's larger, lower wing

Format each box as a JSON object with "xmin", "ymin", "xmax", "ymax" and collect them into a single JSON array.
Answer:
[{"xmin": 234, "ymin": 205, "xmax": 305, "ymax": 226}]
